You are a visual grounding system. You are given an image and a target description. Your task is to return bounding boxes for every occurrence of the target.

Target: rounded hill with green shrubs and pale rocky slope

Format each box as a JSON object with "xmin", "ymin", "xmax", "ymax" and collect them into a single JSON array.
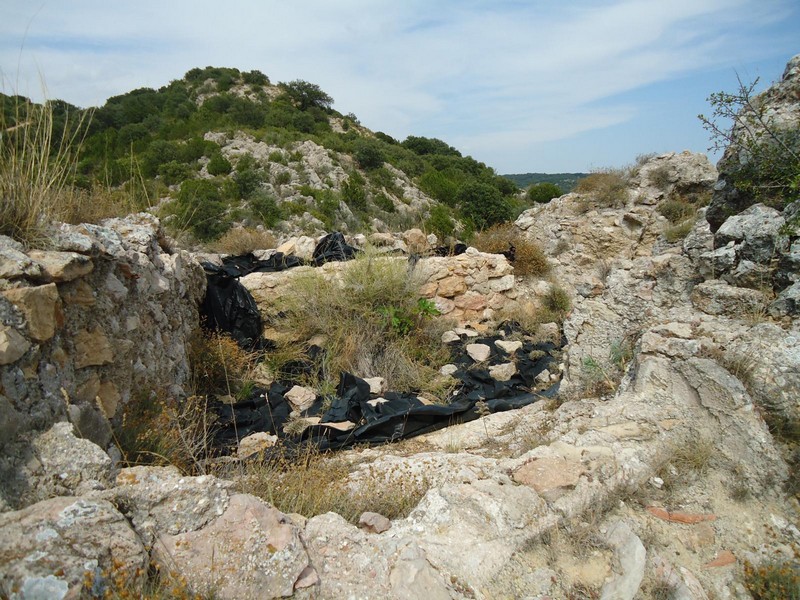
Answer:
[{"xmin": 0, "ymin": 67, "xmax": 540, "ymax": 248}]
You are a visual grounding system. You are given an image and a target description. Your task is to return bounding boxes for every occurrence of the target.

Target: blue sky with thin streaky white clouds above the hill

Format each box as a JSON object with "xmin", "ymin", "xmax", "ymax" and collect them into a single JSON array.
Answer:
[{"xmin": 0, "ymin": 0, "xmax": 800, "ymax": 173}]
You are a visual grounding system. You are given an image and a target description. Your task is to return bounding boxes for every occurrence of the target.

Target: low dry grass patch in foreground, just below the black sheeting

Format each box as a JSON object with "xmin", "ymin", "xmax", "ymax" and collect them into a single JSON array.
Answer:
[{"xmin": 237, "ymin": 446, "xmax": 428, "ymax": 523}]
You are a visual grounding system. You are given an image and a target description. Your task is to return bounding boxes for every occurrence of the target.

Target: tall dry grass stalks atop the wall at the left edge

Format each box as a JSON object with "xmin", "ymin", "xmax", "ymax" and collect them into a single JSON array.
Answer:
[{"xmin": 0, "ymin": 96, "xmax": 88, "ymax": 246}]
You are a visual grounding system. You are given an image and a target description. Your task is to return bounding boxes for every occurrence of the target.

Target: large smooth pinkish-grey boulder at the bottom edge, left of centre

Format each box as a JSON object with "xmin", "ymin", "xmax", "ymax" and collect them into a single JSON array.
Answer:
[{"xmin": 153, "ymin": 494, "xmax": 310, "ymax": 600}]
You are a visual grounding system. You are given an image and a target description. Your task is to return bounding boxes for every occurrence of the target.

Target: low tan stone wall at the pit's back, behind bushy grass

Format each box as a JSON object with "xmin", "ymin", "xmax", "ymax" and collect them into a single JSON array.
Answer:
[{"xmin": 241, "ymin": 248, "xmax": 517, "ymax": 332}]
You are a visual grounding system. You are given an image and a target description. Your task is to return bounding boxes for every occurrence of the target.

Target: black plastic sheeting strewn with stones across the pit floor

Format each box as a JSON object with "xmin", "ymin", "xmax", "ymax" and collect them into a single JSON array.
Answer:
[{"xmin": 210, "ymin": 330, "xmax": 563, "ymax": 453}]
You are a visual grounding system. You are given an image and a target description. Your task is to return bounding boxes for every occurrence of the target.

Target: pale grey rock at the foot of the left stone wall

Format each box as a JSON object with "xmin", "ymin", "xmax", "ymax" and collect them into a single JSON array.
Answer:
[{"xmin": 33, "ymin": 423, "xmax": 113, "ymax": 500}]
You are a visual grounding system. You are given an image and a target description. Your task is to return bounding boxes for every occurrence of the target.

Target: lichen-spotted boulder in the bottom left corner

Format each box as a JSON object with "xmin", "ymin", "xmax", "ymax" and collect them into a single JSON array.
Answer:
[{"xmin": 0, "ymin": 497, "xmax": 148, "ymax": 600}]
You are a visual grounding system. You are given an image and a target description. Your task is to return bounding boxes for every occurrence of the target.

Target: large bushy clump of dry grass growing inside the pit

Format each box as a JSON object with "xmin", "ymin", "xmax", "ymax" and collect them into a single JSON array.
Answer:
[{"xmin": 268, "ymin": 252, "xmax": 449, "ymax": 391}]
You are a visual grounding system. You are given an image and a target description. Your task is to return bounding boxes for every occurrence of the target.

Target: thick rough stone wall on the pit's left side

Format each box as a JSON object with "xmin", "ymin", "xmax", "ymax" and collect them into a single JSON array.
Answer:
[{"xmin": 0, "ymin": 213, "xmax": 205, "ymax": 510}]
